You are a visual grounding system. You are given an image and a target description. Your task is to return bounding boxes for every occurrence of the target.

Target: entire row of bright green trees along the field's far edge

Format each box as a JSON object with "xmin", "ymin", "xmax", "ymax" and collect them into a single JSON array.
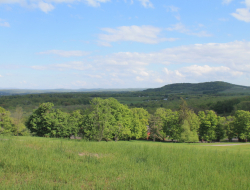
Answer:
[{"xmin": 0, "ymin": 98, "xmax": 250, "ymax": 142}]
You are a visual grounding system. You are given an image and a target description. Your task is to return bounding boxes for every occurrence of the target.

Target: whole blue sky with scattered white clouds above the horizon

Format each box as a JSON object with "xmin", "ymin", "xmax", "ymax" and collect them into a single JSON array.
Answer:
[{"xmin": 0, "ymin": 0, "xmax": 250, "ymax": 89}]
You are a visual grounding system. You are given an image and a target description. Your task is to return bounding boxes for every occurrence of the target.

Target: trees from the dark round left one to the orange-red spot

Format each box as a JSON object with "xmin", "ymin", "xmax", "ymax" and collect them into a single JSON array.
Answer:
[{"xmin": 26, "ymin": 98, "xmax": 149, "ymax": 141}]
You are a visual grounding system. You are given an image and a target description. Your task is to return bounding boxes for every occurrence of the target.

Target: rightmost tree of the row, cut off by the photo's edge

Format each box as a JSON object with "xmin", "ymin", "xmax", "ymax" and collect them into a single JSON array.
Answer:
[{"xmin": 234, "ymin": 110, "xmax": 250, "ymax": 142}]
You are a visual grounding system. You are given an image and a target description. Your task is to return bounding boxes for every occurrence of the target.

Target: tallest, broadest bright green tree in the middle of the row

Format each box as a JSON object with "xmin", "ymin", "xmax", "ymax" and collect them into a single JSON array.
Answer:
[{"xmin": 83, "ymin": 98, "xmax": 137, "ymax": 141}]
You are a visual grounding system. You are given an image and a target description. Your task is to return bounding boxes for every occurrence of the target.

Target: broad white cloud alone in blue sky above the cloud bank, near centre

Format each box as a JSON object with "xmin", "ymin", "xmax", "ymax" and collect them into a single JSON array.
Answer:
[{"xmin": 99, "ymin": 26, "xmax": 176, "ymax": 46}]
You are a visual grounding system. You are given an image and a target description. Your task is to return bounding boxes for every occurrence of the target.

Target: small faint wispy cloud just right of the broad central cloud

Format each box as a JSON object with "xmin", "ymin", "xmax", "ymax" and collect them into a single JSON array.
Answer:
[{"xmin": 166, "ymin": 23, "xmax": 212, "ymax": 37}]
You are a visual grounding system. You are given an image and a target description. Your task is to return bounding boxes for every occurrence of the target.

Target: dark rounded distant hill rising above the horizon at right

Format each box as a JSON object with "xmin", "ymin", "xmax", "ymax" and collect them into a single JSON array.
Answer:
[{"xmin": 143, "ymin": 81, "xmax": 250, "ymax": 94}]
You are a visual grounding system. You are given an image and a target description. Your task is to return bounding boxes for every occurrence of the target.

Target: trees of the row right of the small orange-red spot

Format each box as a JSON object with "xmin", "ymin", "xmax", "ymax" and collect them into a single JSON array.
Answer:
[{"xmin": 150, "ymin": 101, "xmax": 250, "ymax": 142}]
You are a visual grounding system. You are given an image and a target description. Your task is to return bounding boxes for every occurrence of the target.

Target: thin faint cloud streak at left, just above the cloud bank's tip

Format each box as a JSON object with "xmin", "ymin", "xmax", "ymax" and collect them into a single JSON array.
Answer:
[{"xmin": 38, "ymin": 50, "xmax": 90, "ymax": 57}]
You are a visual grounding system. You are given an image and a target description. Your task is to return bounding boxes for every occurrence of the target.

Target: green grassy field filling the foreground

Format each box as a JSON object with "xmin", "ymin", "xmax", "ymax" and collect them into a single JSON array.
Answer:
[{"xmin": 0, "ymin": 137, "xmax": 250, "ymax": 190}]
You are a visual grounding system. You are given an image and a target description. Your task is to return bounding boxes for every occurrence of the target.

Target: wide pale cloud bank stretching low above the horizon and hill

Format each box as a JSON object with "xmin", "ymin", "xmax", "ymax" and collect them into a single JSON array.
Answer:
[{"xmin": 32, "ymin": 41, "xmax": 250, "ymax": 87}]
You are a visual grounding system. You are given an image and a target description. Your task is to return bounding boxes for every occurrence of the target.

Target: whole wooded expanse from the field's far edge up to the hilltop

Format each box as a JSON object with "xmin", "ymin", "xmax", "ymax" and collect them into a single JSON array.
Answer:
[{"xmin": 0, "ymin": 82, "xmax": 250, "ymax": 142}]
